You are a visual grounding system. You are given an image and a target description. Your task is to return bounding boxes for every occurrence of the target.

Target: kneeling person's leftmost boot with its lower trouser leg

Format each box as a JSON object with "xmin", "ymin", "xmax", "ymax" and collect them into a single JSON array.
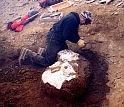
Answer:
[{"xmin": 19, "ymin": 48, "xmax": 37, "ymax": 66}]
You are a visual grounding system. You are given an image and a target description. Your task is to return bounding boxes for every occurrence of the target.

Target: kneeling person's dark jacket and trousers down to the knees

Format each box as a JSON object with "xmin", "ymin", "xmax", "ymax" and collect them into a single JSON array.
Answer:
[{"xmin": 35, "ymin": 12, "xmax": 80, "ymax": 66}]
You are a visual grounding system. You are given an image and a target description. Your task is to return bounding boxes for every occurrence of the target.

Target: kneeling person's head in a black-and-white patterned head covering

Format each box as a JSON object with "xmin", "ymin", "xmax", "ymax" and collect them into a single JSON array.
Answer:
[{"xmin": 79, "ymin": 11, "xmax": 92, "ymax": 25}]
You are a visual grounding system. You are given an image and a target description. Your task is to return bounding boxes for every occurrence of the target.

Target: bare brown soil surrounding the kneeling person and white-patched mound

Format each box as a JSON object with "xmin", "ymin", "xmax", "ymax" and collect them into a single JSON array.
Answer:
[{"xmin": 0, "ymin": 0, "xmax": 124, "ymax": 107}]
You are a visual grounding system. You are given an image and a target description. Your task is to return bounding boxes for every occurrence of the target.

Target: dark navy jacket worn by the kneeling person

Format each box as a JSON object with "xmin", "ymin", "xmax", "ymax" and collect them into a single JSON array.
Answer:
[{"xmin": 52, "ymin": 12, "xmax": 80, "ymax": 43}]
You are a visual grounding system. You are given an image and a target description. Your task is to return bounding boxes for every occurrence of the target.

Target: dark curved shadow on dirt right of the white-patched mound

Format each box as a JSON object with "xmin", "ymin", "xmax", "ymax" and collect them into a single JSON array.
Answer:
[{"xmin": 74, "ymin": 49, "xmax": 110, "ymax": 107}]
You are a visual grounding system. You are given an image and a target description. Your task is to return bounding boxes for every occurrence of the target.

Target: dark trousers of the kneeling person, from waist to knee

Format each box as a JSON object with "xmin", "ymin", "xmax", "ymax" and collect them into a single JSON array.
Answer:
[{"xmin": 35, "ymin": 31, "xmax": 68, "ymax": 66}]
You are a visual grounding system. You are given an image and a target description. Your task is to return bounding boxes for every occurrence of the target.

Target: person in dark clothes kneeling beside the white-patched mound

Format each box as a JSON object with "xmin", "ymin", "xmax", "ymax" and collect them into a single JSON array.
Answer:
[{"xmin": 19, "ymin": 11, "xmax": 92, "ymax": 67}]
